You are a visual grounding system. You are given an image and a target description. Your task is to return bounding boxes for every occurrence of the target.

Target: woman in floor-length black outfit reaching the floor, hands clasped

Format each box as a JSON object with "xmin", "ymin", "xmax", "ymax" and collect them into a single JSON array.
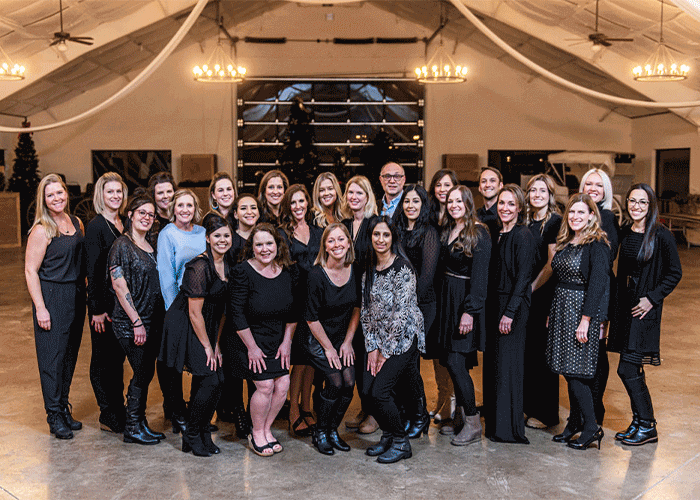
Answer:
[{"xmin": 484, "ymin": 184, "xmax": 535, "ymax": 444}]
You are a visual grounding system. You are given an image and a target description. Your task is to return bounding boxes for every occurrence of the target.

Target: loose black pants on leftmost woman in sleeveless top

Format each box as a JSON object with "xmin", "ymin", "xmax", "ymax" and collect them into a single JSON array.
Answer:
[{"xmin": 32, "ymin": 281, "xmax": 85, "ymax": 412}]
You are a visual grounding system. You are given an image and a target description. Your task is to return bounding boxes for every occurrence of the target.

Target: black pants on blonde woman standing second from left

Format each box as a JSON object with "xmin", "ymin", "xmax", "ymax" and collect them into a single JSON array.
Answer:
[{"xmin": 90, "ymin": 321, "xmax": 126, "ymax": 415}]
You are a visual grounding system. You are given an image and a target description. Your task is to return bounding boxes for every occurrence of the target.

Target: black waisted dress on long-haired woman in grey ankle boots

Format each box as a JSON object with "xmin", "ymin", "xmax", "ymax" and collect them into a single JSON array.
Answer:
[{"xmin": 438, "ymin": 227, "xmax": 491, "ymax": 360}]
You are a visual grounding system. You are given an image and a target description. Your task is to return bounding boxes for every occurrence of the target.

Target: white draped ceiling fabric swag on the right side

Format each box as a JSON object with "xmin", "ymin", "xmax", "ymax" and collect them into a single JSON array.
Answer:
[{"xmin": 450, "ymin": 0, "xmax": 700, "ymax": 108}]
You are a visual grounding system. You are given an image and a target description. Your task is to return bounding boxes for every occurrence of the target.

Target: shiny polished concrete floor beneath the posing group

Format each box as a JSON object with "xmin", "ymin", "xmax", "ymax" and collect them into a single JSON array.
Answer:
[{"xmin": 0, "ymin": 248, "xmax": 700, "ymax": 500}]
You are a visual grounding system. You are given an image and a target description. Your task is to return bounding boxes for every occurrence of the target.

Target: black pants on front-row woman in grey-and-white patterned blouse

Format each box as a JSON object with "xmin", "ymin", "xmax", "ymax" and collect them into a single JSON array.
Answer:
[{"xmin": 363, "ymin": 338, "xmax": 422, "ymax": 437}]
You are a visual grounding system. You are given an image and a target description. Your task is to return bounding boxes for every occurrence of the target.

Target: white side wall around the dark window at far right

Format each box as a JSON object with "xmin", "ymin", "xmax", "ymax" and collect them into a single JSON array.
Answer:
[{"xmin": 632, "ymin": 113, "xmax": 700, "ymax": 195}]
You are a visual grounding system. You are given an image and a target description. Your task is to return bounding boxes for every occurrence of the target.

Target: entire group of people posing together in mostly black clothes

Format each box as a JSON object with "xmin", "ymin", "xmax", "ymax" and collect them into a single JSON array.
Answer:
[{"xmin": 25, "ymin": 163, "xmax": 681, "ymax": 463}]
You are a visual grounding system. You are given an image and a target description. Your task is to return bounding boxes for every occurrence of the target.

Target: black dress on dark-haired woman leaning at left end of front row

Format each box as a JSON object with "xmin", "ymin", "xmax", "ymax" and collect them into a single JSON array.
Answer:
[{"xmin": 158, "ymin": 254, "xmax": 230, "ymax": 376}]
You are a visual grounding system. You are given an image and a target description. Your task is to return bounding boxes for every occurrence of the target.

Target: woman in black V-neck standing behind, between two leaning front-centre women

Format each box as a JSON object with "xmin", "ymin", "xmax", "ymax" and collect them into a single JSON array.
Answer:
[{"xmin": 279, "ymin": 184, "xmax": 323, "ymax": 436}]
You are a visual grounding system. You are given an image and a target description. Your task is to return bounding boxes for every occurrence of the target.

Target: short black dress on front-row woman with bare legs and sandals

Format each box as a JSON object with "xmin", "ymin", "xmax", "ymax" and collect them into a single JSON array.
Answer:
[{"xmin": 228, "ymin": 261, "xmax": 298, "ymax": 380}]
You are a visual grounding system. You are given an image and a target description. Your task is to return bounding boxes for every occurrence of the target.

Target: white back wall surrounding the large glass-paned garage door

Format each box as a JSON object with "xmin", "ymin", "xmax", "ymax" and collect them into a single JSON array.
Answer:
[{"xmin": 0, "ymin": 4, "xmax": 636, "ymax": 186}]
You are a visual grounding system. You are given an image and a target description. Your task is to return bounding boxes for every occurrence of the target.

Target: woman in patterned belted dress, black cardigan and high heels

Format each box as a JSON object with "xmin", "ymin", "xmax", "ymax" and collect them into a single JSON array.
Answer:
[{"xmin": 547, "ymin": 194, "xmax": 609, "ymax": 450}]
